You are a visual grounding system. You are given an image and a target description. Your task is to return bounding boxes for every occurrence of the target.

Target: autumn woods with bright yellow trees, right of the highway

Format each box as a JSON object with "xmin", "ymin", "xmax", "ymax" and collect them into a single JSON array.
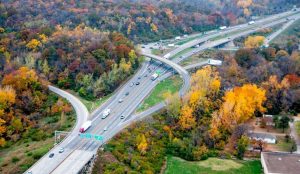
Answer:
[{"xmin": 93, "ymin": 44, "xmax": 300, "ymax": 174}]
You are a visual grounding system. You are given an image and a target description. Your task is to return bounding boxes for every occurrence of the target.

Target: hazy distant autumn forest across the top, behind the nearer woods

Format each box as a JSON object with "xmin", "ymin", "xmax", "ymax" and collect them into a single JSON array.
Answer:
[{"xmin": 0, "ymin": 0, "xmax": 300, "ymax": 42}]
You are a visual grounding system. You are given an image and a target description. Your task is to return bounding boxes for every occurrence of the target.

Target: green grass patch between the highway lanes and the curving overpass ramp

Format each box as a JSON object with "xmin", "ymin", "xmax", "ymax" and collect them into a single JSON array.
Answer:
[{"xmin": 137, "ymin": 75, "xmax": 182, "ymax": 112}]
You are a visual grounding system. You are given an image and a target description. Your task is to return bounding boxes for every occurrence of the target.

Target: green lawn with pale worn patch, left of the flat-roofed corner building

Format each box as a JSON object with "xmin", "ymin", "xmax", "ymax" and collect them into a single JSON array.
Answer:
[{"xmin": 165, "ymin": 156, "xmax": 262, "ymax": 174}]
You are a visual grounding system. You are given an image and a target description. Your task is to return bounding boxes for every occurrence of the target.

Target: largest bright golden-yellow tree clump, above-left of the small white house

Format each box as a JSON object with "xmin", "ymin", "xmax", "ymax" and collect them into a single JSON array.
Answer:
[{"xmin": 211, "ymin": 84, "xmax": 266, "ymax": 135}]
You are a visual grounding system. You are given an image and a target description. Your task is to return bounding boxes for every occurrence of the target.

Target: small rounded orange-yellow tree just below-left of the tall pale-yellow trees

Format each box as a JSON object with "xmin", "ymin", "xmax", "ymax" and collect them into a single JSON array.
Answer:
[{"xmin": 178, "ymin": 105, "xmax": 196, "ymax": 130}]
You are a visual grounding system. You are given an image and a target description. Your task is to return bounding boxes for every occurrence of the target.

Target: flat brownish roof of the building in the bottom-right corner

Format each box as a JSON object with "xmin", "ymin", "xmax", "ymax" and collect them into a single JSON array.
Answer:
[{"xmin": 261, "ymin": 152, "xmax": 300, "ymax": 174}]
